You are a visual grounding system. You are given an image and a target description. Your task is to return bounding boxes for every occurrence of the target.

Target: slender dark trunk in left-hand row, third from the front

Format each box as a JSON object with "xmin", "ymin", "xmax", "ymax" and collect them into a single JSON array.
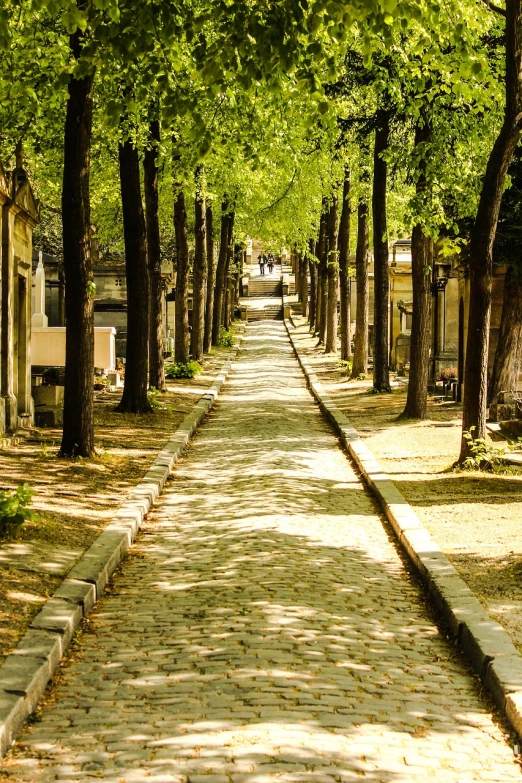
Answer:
[{"xmin": 143, "ymin": 120, "xmax": 166, "ymax": 391}]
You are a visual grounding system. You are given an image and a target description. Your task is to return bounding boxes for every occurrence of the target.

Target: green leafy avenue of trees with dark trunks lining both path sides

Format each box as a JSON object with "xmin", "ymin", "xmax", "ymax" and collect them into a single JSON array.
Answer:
[{"xmin": 0, "ymin": 0, "xmax": 522, "ymax": 461}]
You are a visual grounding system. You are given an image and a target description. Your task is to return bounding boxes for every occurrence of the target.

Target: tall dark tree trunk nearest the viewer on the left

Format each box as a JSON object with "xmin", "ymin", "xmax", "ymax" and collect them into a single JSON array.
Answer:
[{"xmin": 60, "ymin": 24, "xmax": 94, "ymax": 457}]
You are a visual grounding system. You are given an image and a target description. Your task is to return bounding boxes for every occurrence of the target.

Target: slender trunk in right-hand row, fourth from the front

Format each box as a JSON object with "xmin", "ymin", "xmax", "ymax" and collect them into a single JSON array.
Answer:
[{"xmin": 352, "ymin": 199, "xmax": 370, "ymax": 378}]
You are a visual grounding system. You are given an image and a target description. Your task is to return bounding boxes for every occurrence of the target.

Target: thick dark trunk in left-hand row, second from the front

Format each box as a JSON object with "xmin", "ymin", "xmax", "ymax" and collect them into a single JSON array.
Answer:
[{"xmin": 117, "ymin": 139, "xmax": 152, "ymax": 413}]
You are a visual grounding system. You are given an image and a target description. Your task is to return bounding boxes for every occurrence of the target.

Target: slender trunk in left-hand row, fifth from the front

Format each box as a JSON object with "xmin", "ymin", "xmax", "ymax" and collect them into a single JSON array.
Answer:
[{"xmin": 190, "ymin": 166, "xmax": 207, "ymax": 361}]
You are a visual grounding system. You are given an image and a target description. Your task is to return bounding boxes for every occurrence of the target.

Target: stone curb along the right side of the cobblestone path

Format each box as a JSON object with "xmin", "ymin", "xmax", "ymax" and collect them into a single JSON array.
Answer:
[{"xmin": 285, "ymin": 319, "xmax": 522, "ymax": 736}]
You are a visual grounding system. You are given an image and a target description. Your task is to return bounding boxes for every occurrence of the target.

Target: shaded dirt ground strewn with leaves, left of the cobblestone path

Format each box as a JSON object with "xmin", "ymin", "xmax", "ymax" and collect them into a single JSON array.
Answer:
[{"xmin": 0, "ymin": 348, "xmax": 235, "ymax": 663}]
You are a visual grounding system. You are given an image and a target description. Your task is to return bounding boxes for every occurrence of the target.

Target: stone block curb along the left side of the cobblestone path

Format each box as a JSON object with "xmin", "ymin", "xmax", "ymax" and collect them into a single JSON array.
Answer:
[{"xmin": 0, "ymin": 335, "xmax": 242, "ymax": 758}]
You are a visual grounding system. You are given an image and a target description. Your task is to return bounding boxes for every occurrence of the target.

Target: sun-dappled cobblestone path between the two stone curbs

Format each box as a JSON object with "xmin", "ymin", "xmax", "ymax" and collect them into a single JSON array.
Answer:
[{"xmin": 0, "ymin": 322, "xmax": 521, "ymax": 783}]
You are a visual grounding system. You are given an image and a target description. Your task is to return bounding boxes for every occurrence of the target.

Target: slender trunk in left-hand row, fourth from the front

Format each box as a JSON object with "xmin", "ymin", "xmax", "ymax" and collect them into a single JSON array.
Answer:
[{"xmin": 174, "ymin": 183, "xmax": 189, "ymax": 364}]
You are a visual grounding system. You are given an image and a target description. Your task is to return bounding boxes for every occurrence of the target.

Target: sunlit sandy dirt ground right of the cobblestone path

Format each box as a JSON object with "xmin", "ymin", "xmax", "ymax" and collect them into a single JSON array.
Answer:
[{"xmin": 288, "ymin": 318, "xmax": 522, "ymax": 652}]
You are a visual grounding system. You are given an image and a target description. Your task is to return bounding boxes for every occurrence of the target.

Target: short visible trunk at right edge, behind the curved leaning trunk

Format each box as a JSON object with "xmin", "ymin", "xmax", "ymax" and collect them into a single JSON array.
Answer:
[{"xmin": 488, "ymin": 266, "xmax": 522, "ymax": 404}]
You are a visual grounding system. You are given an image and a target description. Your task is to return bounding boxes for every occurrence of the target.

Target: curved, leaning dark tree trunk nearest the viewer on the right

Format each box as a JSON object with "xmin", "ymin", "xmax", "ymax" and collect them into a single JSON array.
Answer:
[{"xmin": 458, "ymin": 0, "xmax": 522, "ymax": 463}]
